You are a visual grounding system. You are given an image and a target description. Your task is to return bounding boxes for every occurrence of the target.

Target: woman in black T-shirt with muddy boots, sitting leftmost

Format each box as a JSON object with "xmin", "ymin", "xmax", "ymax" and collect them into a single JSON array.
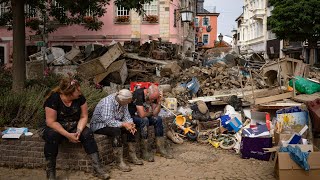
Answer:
[{"xmin": 43, "ymin": 78, "xmax": 109, "ymax": 179}]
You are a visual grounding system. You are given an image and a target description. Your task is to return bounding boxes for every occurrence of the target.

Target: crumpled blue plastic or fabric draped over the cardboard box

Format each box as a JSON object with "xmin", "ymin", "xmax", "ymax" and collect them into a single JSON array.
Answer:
[{"xmin": 279, "ymin": 145, "xmax": 310, "ymax": 171}]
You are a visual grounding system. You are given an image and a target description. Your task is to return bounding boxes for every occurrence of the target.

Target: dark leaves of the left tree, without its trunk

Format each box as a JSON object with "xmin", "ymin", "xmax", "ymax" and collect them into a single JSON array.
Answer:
[{"xmin": 0, "ymin": 0, "xmax": 152, "ymax": 34}]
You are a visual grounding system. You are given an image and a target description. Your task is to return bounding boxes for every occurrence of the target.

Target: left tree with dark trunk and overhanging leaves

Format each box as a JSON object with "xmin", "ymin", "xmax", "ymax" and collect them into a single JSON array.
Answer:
[{"xmin": 0, "ymin": 0, "xmax": 152, "ymax": 92}]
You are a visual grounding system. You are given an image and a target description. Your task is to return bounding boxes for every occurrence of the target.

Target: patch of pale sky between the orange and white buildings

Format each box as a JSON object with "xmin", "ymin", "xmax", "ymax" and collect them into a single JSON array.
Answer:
[{"xmin": 204, "ymin": 0, "xmax": 243, "ymax": 35}]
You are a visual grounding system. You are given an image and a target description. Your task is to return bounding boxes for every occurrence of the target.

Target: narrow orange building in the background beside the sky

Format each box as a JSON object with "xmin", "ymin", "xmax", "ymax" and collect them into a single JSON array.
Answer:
[{"xmin": 194, "ymin": 0, "xmax": 219, "ymax": 48}]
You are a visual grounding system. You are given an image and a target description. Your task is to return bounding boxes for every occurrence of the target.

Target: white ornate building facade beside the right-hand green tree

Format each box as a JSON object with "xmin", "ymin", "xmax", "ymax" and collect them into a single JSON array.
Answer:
[{"xmin": 234, "ymin": 0, "xmax": 303, "ymax": 59}]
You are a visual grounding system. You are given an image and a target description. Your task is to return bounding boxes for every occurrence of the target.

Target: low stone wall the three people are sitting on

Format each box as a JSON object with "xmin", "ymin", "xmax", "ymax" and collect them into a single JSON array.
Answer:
[{"xmin": 0, "ymin": 133, "xmax": 113, "ymax": 172}]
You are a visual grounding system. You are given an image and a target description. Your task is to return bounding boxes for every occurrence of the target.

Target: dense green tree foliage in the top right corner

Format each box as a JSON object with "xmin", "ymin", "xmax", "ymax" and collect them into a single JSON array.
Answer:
[{"xmin": 268, "ymin": 0, "xmax": 320, "ymax": 42}]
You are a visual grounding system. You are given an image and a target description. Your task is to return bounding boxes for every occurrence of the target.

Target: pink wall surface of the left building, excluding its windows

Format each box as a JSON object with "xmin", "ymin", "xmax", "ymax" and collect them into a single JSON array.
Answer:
[{"xmin": 0, "ymin": 0, "xmax": 181, "ymax": 62}]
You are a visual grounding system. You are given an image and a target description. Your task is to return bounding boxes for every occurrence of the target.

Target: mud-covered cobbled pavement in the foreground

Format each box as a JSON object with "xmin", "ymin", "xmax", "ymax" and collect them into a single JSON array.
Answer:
[{"xmin": 0, "ymin": 143, "xmax": 275, "ymax": 180}]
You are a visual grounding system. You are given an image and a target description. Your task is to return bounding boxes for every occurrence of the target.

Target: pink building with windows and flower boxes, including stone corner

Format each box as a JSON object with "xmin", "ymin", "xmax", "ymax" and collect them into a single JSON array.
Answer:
[{"xmin": 0, "ymin": 0, "xmax": 196, "ymax": 63}]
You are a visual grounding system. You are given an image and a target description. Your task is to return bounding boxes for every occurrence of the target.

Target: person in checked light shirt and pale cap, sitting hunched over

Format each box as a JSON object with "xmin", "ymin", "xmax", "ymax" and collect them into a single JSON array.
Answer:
[{"xmin": 90, "ymin": 89, "xmax": 143, "ymax": 172}]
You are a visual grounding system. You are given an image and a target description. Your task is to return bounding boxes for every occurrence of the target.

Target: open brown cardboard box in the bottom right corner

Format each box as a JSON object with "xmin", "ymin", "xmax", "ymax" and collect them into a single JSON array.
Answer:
[{"xmin": 275, "ymin": 152, "xmax": 320, "ymax": 180}]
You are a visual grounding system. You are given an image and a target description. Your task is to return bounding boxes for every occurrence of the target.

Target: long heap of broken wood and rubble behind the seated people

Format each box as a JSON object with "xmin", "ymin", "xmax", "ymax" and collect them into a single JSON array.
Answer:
[{"xmin": 27, "ymin": 39, "xmax": 320, "ymax": 101}]
